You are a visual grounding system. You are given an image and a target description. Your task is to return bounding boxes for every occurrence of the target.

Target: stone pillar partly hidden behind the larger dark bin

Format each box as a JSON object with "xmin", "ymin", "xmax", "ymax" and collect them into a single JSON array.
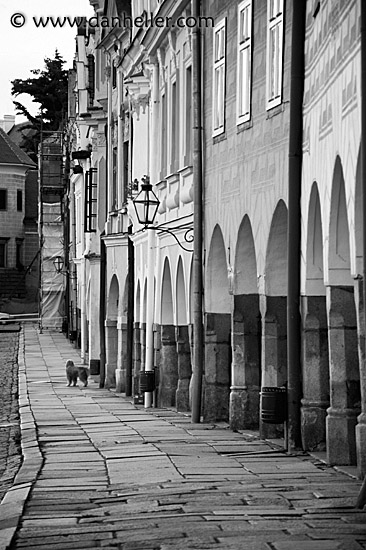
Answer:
[{"xmin": 260, "ymin": 296, "xmax": 288, "ymax": 438}]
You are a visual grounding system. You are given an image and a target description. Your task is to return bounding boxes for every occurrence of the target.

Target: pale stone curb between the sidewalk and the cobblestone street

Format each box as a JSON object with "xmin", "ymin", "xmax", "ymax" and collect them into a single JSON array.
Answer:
[{"xmin": 0, "ymin": 327, "xmax": 43, "ymax": 550}]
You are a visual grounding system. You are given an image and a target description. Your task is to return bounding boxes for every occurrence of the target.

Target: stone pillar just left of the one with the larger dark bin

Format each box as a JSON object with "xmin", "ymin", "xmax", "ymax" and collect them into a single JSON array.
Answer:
[{"xmin": 230, "ymin": 295, "xmax": 261, "ymax": 430}]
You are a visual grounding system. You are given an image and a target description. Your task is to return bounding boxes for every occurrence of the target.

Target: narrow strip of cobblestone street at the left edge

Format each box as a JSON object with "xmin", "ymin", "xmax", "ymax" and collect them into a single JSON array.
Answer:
[{"xmin": 0, "ymin": 332, "xmax": 21, "ymax": 501}]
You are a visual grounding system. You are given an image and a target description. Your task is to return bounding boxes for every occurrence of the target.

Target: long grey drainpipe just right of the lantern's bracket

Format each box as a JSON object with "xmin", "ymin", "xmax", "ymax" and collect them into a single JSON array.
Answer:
[{"xmin": 191, "ymin": 0, "xmax": 204, "ymax": 423}]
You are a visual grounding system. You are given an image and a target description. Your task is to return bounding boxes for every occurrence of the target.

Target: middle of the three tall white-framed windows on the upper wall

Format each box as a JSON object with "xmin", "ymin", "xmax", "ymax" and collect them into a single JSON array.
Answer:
[{"xmin": 237, "ymin": 0, "xmax": 252, "ymax": 124}]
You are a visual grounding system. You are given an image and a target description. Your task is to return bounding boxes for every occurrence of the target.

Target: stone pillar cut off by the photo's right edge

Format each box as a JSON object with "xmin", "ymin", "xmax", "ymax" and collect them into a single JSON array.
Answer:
[{"xmin": 355, "ymin": 278, "xmax": 366, "ymax": 479}]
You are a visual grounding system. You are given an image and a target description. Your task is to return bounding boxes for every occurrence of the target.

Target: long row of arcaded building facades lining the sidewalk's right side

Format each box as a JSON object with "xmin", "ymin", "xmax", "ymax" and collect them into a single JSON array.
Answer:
[{"xmin": 63, "ymin": 0, "xmax": 366, "ymax": 473}]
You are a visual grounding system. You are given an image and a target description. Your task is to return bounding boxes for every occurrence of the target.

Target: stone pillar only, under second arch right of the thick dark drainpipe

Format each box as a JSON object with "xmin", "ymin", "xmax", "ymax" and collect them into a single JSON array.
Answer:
[{"xmin": 327, "ymin": 286, "xmax": 361, "ymax": 465}]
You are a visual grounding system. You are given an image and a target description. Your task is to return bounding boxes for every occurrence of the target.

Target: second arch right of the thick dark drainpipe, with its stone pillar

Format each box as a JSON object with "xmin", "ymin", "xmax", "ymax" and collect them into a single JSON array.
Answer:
[{"xmin": 327, "ymin": 156, "xmax": 361, "ymax": 464}]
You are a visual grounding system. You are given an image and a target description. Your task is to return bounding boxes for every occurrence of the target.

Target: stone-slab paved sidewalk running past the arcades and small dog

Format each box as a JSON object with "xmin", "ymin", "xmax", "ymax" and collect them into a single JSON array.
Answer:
[{"xmin": 0, "ymin": 326, "xmax": 366, "ymax": 550}]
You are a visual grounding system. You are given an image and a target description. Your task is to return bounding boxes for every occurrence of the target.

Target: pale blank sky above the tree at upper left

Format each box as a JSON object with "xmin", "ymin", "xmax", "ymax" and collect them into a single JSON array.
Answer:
[{"xmin": 0, "ymin": 0, "xmax": 94, "ymax": 123}]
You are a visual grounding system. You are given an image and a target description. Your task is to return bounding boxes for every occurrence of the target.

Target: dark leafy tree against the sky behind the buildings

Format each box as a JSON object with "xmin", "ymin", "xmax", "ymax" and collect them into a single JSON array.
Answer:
[{"xmin": 11, "ymin": 50, "xmax": 68, "ymax": 160}]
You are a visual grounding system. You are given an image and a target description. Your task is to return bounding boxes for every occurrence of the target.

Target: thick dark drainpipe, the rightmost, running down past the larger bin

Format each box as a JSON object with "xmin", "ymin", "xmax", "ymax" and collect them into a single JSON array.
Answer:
[{"xmin": 287, "ymin": 0, "xmax": 306, "ymax": 451}]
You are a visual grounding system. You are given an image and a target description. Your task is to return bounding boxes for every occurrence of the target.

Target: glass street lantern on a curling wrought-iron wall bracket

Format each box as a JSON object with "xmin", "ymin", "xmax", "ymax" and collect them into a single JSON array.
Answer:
[{"xmin": 132, "ymin": 176, "xmax": 194, "ymax": 252}]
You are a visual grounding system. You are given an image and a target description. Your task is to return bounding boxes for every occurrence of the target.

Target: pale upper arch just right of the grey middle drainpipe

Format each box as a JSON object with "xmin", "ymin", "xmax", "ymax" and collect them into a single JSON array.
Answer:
[{"xmin": 205, "ymin": 225, "xmax": 231, "ymax": 313}]
